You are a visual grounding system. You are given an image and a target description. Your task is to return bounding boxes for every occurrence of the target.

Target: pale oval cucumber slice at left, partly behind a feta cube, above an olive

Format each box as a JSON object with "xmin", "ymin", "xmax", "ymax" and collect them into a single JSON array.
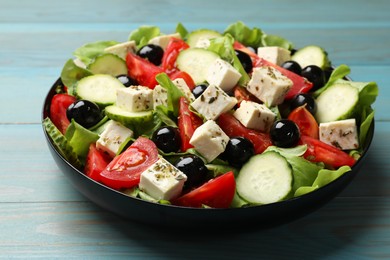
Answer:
[{"xmin": 76, "ymin": 74, "xmax": 125, "ymax": 107}]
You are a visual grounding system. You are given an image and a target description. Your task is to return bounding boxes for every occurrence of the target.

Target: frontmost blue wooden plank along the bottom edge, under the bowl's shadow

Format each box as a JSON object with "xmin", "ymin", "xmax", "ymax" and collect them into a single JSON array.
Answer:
[{"xmin": 0, "ymin": 197, "xmax": 390, "ymax": 259}]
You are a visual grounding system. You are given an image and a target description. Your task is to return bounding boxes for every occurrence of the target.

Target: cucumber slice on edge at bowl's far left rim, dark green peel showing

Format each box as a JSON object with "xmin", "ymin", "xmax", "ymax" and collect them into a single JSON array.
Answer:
[{"xmin": 42, "ymin": 117, "xmax": 82, "ymax": 170}]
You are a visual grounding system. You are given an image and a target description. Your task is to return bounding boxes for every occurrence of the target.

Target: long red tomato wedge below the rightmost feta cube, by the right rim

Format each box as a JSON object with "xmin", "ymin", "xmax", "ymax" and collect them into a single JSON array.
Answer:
[{"xmin": 300, "ymin": 135, "xmax": 356, "ymax": 168}]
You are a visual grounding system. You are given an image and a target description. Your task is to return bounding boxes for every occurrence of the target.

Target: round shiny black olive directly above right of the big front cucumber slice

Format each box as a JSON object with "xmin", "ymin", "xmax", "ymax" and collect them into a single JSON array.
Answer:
[{"xmin": 270, "ymin": 119, "xmax": 300, "ymax": 148}]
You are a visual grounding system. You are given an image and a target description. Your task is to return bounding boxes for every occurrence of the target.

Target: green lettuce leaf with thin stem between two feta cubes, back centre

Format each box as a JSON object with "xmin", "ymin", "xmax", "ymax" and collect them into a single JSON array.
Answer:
[{"xmin": 207, "ymin": 34, "xmax": 250, "ymax": 86}]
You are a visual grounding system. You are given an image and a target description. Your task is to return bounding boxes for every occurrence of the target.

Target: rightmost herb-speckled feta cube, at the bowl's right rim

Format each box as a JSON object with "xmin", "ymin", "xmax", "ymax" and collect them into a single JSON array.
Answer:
[{"xmin": 319, "ymin": 119, "xmax": 359, "ymax": 150}]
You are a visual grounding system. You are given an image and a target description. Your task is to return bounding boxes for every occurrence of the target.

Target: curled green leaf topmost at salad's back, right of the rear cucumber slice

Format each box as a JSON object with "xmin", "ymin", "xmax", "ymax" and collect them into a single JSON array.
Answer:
[{"xmin": 224, "ymin": 21, "xmax": 264, "ymax": 48}]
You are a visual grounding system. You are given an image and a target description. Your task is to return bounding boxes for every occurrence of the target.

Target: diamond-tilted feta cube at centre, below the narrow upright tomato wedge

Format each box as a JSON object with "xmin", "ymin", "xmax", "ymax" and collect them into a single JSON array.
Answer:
[{"xmin": 190, "ymin": 120, "xmax": 229, "ymax": 162}]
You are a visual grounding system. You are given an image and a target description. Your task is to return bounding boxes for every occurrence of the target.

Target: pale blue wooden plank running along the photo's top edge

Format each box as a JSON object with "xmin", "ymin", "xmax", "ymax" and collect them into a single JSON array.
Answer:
[{"xmin": 0, "ymin": 0, "xmax": 388, "ymax": 27}]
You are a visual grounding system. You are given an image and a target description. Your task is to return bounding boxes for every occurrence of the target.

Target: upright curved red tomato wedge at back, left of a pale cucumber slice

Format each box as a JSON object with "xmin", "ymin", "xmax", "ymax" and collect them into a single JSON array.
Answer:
[{"xmin": 161, "ymin": 38, "xmax": 190, "ymax": 74}]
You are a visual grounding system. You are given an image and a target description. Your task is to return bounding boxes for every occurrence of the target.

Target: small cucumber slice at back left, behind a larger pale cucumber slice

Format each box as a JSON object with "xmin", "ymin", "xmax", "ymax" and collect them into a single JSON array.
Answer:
[{"xmin": 87, "ymin": 53, "xmax": 127, "ymax": 77}]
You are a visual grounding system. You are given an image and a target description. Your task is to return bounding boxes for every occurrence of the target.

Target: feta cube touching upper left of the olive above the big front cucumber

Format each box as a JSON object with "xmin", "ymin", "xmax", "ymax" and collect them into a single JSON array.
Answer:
[{"xmin": 233, "ymin": 100, "xmax": 275, "ymax": 132}]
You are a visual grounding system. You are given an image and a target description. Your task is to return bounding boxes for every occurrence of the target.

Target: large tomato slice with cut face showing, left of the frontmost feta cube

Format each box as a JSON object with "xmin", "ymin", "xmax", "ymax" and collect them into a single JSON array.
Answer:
[{"xmin": 99, "ymin": 137, "xmax": 158, "ymax": 190}]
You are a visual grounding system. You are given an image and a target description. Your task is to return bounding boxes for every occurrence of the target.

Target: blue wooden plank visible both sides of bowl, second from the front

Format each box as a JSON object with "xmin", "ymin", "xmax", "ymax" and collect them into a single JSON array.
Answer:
[{"xmin": 0, "ymin": 122, "xmax": 390, "ymax": 203}]
